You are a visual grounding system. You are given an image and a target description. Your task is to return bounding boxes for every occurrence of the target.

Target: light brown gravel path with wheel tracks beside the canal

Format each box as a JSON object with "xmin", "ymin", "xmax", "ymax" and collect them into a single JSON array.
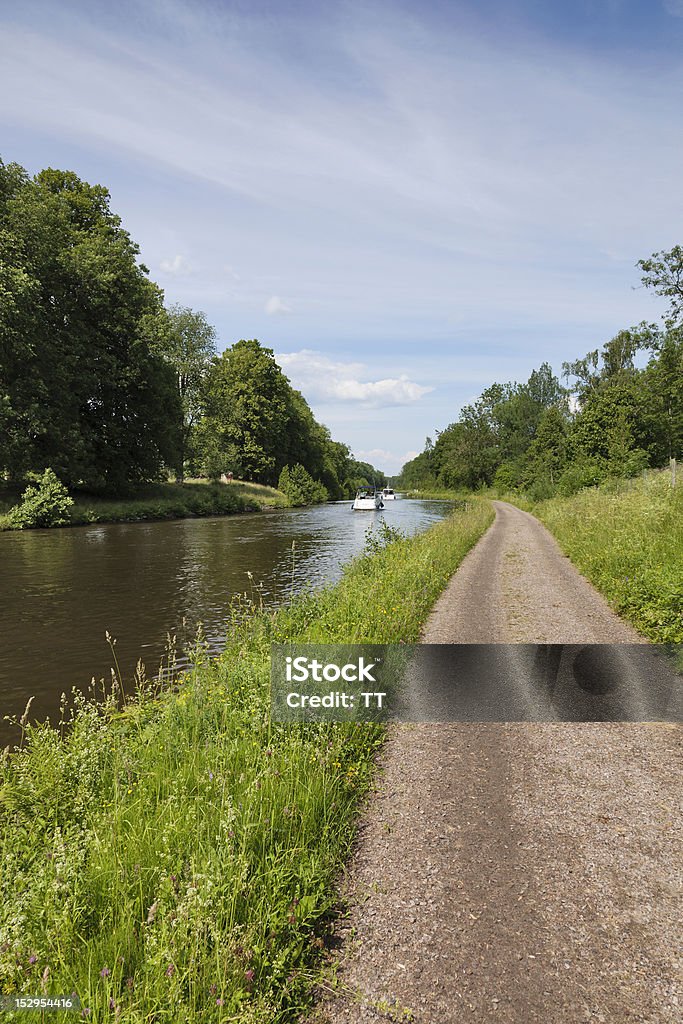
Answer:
[{"xmin": 315, "ymin": 502, "xmax": 683, "ymax": 1024}]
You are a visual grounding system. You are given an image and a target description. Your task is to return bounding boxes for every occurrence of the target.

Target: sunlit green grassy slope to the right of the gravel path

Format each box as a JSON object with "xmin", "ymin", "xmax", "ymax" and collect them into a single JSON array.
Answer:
[{"xmin": 532, "ymin": 473, "xmax": 683, "ymax": 643}]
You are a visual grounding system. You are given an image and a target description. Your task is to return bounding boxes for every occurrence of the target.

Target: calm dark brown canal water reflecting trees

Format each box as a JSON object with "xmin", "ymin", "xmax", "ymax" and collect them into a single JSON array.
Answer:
[{"xmin": 0, "ymin": 500, "xmax": 451, "ymax": 742}]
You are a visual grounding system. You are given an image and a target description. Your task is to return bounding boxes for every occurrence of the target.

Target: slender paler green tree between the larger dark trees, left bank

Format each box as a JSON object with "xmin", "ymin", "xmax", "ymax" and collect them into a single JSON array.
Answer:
[{"xmin": 144, "ymin": 305, "xmax": 216, "ymax": 483}]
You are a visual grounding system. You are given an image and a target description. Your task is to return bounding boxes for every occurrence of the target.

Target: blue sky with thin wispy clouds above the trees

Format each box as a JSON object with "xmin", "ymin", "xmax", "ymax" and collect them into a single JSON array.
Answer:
[{"xmin": 0, "ymin": 0, "xmax": 683, "ymax": 473}]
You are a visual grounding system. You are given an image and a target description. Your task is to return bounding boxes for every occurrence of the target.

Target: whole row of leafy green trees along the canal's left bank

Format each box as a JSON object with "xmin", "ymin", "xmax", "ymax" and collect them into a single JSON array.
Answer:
[{"xmin": 0, "ymin": 154, "xmax": 385, "ymax": 501}]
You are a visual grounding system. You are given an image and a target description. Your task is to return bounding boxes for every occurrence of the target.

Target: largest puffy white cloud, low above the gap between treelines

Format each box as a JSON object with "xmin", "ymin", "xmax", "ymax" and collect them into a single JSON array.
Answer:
[{"xmin": 275, "ymin": 348, "xmax": 434, "ymax": 407}]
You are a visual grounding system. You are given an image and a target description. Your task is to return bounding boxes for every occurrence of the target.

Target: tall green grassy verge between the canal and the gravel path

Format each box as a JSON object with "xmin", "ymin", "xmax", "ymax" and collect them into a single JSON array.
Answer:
[{"xmin": 0, "ymin": 501, "xmax": 493, "ymax": 1024}]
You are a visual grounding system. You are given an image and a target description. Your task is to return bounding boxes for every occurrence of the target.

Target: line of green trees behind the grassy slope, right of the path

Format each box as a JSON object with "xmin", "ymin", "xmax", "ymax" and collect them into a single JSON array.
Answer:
[{"xmin": 397, "ymin": 246, "xmax": 683, "ymax": 501}]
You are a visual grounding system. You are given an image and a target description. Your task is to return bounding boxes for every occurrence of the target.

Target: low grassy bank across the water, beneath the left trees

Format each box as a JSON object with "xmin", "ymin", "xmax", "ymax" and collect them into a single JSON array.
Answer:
[{"xmin": 0, "ymin": 480, "xmax": 289, "ymax": 529}]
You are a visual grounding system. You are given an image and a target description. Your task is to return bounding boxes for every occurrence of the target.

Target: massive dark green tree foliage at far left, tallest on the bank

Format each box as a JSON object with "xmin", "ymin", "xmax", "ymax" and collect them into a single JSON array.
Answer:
[{"xmin": 0, "ymin": 162, "xmax": 178, "ymax": 490}]
